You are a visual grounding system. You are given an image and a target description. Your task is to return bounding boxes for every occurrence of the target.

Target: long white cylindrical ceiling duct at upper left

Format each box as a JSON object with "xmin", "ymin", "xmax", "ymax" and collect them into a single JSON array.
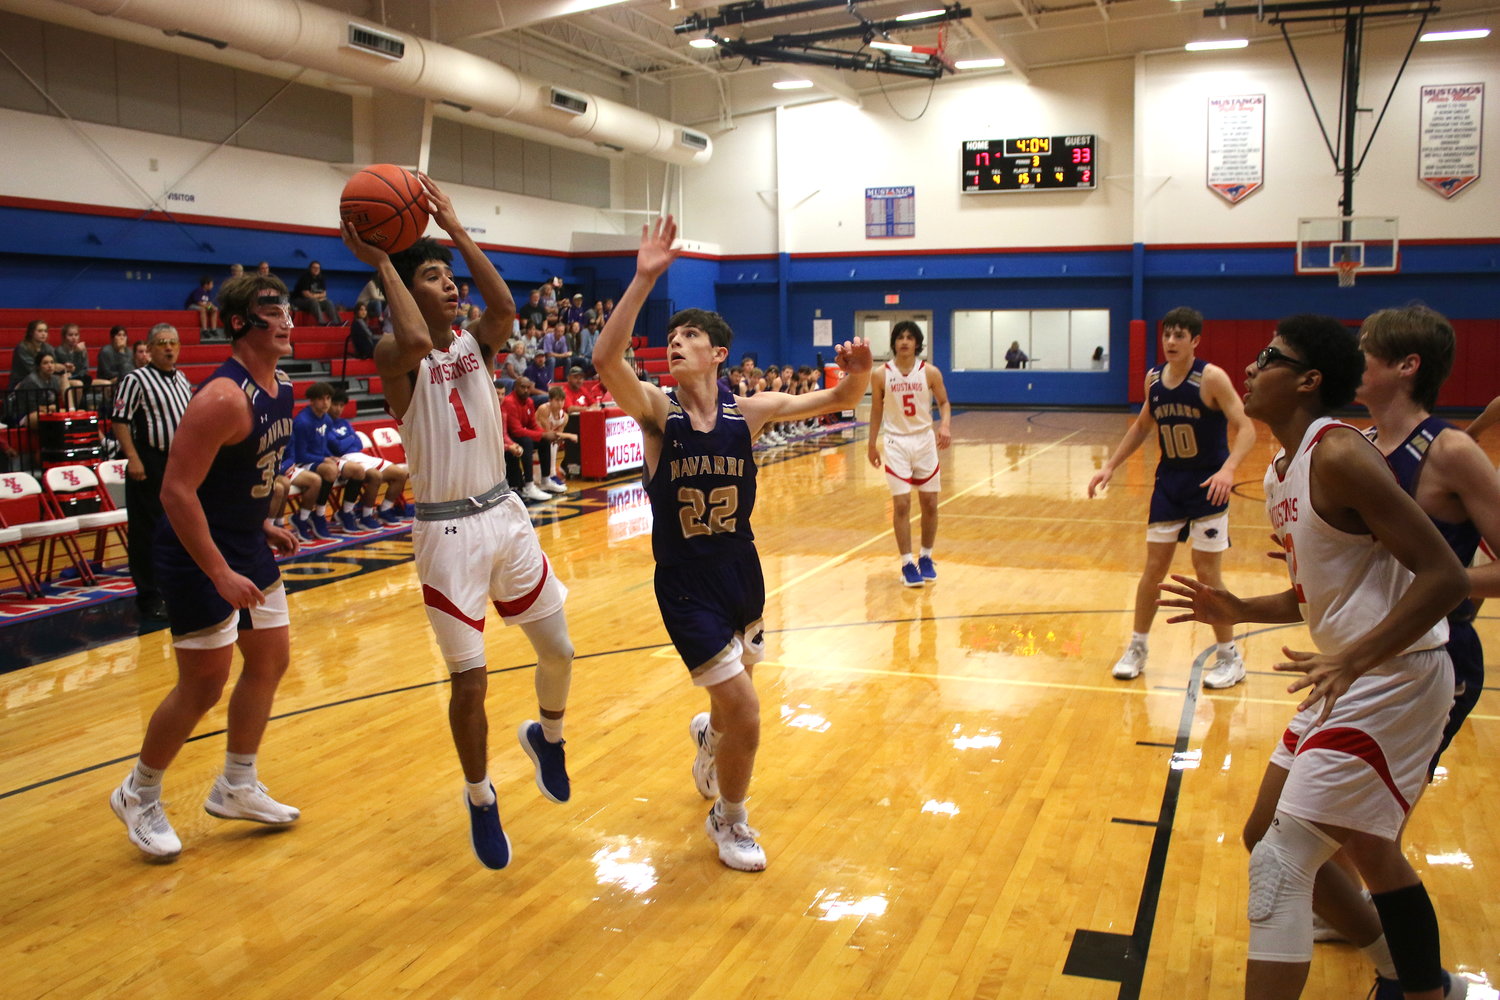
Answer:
[{"xmin": 35, "ymin": 0, "xmax": 714, "ymax": 163}]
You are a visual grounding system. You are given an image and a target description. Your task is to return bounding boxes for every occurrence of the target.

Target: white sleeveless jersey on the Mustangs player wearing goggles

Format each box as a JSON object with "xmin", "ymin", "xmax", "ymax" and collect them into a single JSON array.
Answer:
[{"xmin": 1265, "ymin": 417, "xmax": 1448, "ymax": 652}]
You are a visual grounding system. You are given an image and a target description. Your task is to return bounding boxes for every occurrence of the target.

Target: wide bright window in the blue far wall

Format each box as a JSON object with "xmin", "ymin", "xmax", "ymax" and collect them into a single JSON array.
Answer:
[{"xmin": 953, "ymin": 309, "xmax": 1110, "ymax": 372}]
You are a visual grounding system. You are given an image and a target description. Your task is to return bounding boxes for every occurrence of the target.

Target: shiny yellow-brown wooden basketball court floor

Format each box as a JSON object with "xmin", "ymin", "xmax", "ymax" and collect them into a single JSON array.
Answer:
[{"xmin": 0, "ymin": 412, "xmax": 1500, "ymax": 1000}]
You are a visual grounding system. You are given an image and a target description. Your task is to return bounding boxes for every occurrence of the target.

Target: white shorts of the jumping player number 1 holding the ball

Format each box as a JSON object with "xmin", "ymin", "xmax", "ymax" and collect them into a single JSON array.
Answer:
[{"xmin": 411, "ymin": 493, "xmax": 567, "ymax": 673}]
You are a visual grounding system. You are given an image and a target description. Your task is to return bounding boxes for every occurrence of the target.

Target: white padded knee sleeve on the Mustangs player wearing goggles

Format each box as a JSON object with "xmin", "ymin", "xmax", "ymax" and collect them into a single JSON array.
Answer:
[{"xmin": 1248, "ymin": 811, "xmax": 1338, "ymax": 963}]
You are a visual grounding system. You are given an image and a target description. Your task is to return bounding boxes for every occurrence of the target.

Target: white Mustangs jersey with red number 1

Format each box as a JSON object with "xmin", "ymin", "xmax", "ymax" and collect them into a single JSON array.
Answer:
[{"xmin": 401, "ymin": 330, "xmax": 506, "ymax": 504}]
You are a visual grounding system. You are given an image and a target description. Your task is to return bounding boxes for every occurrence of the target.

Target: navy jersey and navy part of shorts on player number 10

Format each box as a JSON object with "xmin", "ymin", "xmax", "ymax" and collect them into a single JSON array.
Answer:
[{"xmin": 1146, "ymin": 358, "xmax": 1229, "ymax": 525}]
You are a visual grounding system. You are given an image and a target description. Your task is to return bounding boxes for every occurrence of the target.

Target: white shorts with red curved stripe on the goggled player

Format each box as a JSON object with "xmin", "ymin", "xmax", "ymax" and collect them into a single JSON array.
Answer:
[{"xmin": 1271, "ymin": 649, "xmax": 1454, "ymax": 840}]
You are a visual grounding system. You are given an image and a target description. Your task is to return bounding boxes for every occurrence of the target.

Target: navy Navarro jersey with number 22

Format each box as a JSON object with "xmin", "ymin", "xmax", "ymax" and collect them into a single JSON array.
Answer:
[{"xmin": 647, "ymin": 387, "xmax": 756, "ymax": 565}]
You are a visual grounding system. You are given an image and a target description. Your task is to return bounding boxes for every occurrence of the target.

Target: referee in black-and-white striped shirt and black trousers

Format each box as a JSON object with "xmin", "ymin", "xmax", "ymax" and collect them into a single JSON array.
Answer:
[{"xmin": 114, "ymin": 322, "xmax": 192, "ymax": 621}]
